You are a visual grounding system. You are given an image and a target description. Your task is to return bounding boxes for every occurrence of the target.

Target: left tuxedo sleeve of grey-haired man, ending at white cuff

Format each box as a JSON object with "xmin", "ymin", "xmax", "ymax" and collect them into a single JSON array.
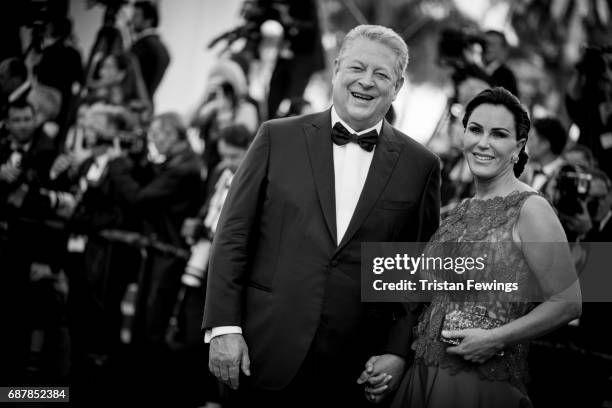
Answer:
[{"xmin": 202, "ymin": 123, "xmax": 270, "ymax": 329}]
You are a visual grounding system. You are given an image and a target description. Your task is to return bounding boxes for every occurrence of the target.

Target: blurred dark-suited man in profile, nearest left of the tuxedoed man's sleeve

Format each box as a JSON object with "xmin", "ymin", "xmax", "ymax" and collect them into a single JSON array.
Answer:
[{"xmin": 109, "ymin": 113, "xmax": 203, "ymax": 348}]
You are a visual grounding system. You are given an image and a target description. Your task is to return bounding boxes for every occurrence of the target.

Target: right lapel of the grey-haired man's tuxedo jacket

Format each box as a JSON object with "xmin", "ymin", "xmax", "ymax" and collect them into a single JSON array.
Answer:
[{"xmin": 336, "ymin": 121, "xmax": 402, "ymax": 253}]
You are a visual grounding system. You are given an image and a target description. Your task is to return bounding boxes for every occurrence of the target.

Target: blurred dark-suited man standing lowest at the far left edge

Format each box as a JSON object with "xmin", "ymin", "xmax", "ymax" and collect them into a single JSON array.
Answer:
[{"xmin": 0, "ymin": 99, "xmax": 57, "ymax": 382}]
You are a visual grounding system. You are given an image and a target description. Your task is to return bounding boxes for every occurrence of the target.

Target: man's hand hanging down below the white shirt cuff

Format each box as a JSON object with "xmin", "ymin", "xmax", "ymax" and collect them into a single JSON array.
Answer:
[{"xmin": 208, "ymin": 333, "xmax": 251, "ymax": 390}]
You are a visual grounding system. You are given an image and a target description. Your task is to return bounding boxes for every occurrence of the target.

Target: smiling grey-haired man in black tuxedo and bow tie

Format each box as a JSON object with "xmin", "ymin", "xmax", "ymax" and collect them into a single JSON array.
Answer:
[{"xmin": 203, "ymin": 25, "xmax": 440, "ymax": 407}]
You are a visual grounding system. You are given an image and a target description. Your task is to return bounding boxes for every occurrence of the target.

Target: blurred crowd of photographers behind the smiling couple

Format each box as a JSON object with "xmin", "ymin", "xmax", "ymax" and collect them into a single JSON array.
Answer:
[{"xmin": 0, "ymin": 0, "xmax": 612, "ymax": 407}]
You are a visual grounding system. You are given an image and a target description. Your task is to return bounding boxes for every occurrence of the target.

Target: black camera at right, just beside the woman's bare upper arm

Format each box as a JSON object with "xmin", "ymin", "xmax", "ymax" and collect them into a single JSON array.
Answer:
[{"xmin": 553, "ymin": 164, "xmax": 593, "ymax": 215}]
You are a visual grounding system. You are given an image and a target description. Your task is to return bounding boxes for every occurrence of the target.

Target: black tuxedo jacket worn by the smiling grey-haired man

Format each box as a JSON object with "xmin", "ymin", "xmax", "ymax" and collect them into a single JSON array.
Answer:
[{"xmin": 203, "ymin": 110, "xmax": 440, "ymax": 390}]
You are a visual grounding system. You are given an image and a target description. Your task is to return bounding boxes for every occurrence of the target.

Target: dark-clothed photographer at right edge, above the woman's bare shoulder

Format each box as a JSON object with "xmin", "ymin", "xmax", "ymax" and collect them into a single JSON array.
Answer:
[{"xmin": 565, "ymin": 46, "xmax": 612, "ymax": 177}]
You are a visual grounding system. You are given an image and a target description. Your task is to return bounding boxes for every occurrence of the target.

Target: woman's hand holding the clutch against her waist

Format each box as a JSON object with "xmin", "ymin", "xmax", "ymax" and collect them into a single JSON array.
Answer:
[{"xmin": 442, "ymin": 329, "xmax": 504, "ymax": 363}]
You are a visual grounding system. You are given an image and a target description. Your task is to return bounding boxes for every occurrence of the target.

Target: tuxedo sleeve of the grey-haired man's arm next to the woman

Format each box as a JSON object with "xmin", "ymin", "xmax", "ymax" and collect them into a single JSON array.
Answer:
[{"xmin": 385, "ymin": 156, "xmax": 441, "ymax": 358}]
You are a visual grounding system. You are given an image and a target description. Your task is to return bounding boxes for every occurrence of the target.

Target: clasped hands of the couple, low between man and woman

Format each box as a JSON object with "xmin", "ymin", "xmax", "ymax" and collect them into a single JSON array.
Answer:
[{"xmin": 357, "ymin": 354, "xmax": 405, "ymax": 403}]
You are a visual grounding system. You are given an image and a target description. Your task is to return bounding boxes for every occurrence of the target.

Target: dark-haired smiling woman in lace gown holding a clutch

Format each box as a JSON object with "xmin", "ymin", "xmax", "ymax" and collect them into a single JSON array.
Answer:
[{"xmin": 366, "ymin": 88, "xmax": 581, "ymax": 408}]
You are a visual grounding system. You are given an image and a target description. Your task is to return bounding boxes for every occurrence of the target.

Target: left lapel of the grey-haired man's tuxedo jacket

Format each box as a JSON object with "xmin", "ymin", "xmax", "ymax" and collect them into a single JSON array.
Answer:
[{"xmin": 304, "ymin": 109, "xmax": 337, "ymax": 244}]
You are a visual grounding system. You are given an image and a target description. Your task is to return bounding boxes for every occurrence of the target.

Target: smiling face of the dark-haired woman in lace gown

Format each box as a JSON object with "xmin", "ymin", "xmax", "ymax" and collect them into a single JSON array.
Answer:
[{"xmin": 463, "ymin": 104, "xmax": 525, "ymax": 180}]
